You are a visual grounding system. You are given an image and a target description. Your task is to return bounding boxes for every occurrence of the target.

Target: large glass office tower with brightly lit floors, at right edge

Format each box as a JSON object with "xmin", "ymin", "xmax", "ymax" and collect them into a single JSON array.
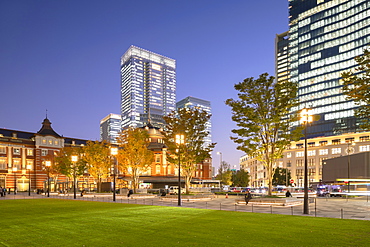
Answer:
[{"xmin": 289, "ymin": 0, "xmax": 370, "ymax": 137}]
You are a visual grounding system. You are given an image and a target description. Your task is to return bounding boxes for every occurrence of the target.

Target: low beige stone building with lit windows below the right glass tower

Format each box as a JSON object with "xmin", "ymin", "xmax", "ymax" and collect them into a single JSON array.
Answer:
[{"xmin": 240, "ymin": 132, "xmax": 370, "ymax": 187}]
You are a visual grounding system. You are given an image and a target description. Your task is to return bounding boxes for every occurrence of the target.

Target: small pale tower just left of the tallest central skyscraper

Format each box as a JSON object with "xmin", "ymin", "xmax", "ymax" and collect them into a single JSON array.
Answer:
[{"xmin": 100, "ymin": 113, "xmax": 121, "ymax": 143}]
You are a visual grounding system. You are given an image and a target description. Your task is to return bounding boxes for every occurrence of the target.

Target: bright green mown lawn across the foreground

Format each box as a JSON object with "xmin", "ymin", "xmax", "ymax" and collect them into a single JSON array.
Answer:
[{"xmin": 0, "ymin": 199, "xmax": 370, "ymax": 247}]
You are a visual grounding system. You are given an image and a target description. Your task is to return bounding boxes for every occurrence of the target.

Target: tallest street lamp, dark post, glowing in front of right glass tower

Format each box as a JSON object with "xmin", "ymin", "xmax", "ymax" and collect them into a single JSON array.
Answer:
[{"xmin": 301, "ymin": 109, "xmax": 312, "ymax": 214}]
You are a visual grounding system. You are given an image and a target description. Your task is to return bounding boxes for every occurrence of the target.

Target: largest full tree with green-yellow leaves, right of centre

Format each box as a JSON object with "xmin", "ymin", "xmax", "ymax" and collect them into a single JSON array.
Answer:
[{"xmin": 226, "ymin": 73, "xmax": 302, "ymax": 195}]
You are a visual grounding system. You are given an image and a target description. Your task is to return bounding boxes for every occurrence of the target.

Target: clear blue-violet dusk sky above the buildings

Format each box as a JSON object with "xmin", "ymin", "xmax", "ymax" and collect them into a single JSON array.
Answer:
[{"xmin": 0, "ymin": 0, "xmax": 288, "ymax": 168}]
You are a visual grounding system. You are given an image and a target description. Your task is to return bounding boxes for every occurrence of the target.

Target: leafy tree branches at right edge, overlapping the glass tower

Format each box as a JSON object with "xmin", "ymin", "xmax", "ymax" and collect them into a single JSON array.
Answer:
[{"xmin": 341, "ymin": 49, "xmax": 370, "ymax": 130}]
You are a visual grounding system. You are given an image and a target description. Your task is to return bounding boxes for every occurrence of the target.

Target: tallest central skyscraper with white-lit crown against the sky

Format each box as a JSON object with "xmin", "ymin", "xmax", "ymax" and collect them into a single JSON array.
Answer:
[{"xmin": 121, "ymin": 46, "xmax": 176, "ymax": 128}]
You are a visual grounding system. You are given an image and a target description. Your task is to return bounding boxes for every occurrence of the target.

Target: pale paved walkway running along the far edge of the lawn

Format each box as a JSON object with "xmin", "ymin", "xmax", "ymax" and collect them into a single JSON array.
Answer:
[{"xmin": 0, "ymin": 192, "xmax": 370, "ymax": 220}]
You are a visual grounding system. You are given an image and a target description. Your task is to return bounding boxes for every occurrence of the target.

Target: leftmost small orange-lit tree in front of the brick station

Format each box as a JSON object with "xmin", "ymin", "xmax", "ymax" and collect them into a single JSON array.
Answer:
[{"xmin": 55, "ymin": 147, "xmax": 86, "ymax": 198}]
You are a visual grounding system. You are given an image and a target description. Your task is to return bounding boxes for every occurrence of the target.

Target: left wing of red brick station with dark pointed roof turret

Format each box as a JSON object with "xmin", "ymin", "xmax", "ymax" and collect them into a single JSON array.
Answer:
[{"xmin": 0, "ymin": 118, "xmax": 89, "ymax": 192}]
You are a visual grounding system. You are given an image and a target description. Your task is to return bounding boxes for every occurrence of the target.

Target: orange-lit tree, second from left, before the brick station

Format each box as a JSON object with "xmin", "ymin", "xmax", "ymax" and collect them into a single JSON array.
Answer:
[{"xmin": 83, "ymin": 141, "xmax": 112, "ymax": 192}]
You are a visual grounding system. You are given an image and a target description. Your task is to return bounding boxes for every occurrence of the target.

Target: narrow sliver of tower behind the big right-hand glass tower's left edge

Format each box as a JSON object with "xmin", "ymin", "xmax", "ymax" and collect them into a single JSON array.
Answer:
[{"xmin": 275, "ymin": 31, "xmax": 290, "ymax": 82}]
